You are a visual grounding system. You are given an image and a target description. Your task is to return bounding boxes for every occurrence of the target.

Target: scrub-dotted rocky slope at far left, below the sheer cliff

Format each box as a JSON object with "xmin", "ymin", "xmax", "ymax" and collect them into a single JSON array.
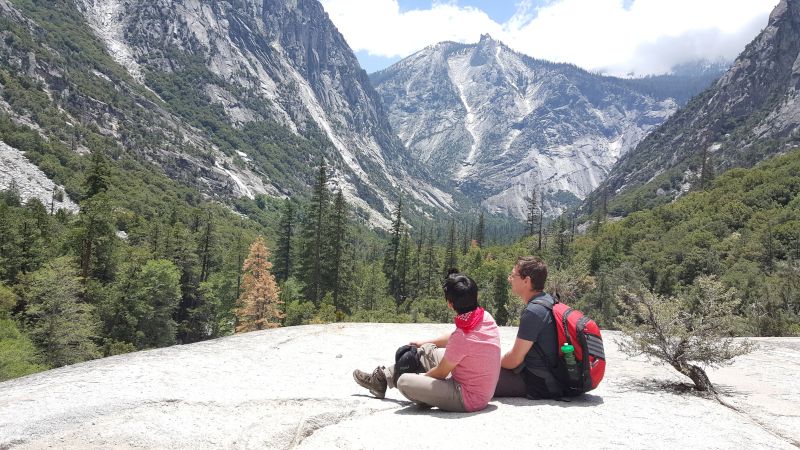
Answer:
[{"xmin": 0, "ymin": 0, "xmax": 278, "ymax": 202}]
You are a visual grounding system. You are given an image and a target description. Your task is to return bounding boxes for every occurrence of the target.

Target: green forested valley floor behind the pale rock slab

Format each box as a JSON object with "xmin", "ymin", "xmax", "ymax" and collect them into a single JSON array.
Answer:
[{"xmin": 0, "ymin": 143, "xmax": 800, "ymax": 379}]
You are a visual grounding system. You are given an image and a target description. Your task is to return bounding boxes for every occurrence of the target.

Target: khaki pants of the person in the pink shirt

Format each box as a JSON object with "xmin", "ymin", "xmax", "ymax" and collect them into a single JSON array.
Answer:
[{"xmin": 383, "ymin": 344, "xmax": 466, "ymax": 412}]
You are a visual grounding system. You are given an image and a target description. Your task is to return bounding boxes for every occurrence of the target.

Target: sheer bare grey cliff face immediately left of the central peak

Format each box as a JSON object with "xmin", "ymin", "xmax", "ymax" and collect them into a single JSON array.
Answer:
[{"xmin": 79, "ymin": 0, "xmax": 452, "ymax": 224}]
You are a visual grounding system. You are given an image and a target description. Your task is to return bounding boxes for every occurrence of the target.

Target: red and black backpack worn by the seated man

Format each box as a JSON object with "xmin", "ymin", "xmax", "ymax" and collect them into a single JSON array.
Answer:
[{"xmin": 534, "ymin": 296, "xmax": 606, "ymax": 396}]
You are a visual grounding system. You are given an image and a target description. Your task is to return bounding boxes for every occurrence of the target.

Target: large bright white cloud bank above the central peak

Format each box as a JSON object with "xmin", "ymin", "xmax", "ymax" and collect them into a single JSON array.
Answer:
[{"xmin": 322, "ymin": 0, "xmax": 778, "ymax": 75}]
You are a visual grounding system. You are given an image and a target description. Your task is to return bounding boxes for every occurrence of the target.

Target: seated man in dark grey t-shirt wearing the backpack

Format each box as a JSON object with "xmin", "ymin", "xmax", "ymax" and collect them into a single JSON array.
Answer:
[{"xmin": 494, "ymin": 256, "xmax": 562, "ymax": 399}]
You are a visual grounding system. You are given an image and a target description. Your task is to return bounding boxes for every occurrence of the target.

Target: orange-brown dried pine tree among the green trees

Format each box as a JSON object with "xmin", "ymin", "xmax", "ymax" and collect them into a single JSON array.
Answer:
[{"xmin": 236, "ymin": 236, "xmax": 283, "ymax": 333}]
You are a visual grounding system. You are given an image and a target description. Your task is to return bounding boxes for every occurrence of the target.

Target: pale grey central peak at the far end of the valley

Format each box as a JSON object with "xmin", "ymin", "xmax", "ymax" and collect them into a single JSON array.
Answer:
[{"xmin": 370, "ymin": 35, "xmax": 720, "ymax": 218}]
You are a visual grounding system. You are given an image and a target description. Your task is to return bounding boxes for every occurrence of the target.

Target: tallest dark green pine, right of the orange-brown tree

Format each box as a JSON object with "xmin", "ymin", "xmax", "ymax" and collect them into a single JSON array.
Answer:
[{"xmin": 299, "ymin": 159, "xmax": 330, "ymax": 306}]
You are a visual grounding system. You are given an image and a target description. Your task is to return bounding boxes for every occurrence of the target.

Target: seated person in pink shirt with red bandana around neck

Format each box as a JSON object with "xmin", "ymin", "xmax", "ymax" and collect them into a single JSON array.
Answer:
[{"xmin": 353, "ymin": 273, "xmax": 500, "ymax": 412}]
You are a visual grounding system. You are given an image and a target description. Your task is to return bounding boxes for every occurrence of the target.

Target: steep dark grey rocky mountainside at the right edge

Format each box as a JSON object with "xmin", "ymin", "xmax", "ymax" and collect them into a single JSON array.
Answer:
[{"xmin": 585, "ymin": 0, "xmax": 800, "ymax": 214}]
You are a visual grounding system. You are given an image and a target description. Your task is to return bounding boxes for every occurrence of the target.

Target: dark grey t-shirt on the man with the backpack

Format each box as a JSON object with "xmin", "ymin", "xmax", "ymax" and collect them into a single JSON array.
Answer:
[{"xmin": 517, "ymin": 292, "xmax": 558, "ymax": 373}]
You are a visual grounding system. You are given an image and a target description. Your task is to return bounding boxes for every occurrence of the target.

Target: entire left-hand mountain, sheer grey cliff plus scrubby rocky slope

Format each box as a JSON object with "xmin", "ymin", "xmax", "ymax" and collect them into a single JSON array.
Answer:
[{"xmin": 0, "ymin": 0, "xmax": 453, "ymax": 226}]
